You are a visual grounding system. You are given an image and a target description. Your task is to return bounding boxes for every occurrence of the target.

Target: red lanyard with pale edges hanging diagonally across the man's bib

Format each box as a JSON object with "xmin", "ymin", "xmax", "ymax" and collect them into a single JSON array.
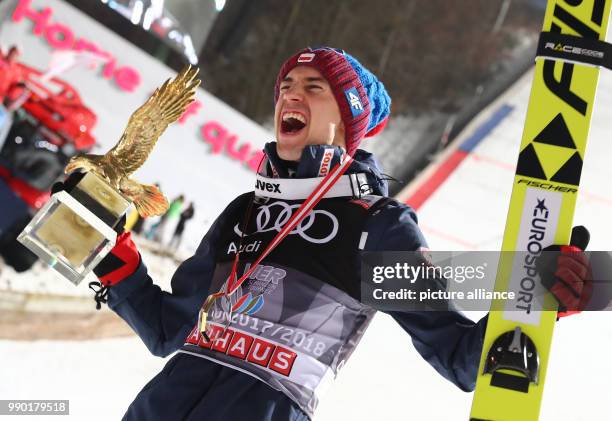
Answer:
[{"xmin": 198, "ymin": 154, "xmax": 353, "ymax": 338}]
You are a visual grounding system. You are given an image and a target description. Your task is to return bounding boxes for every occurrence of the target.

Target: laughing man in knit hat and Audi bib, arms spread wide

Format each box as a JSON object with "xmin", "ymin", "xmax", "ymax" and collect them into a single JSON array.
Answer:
[{"xmin": 88, "ymin": 48, "xmax": 592, "ymax": 421}]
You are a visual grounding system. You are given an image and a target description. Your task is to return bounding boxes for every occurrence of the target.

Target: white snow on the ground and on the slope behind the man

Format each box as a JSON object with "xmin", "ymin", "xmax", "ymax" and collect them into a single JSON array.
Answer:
[{"xmin": 0, "ymin": 65, "xmax": 612, "ymax": 421}]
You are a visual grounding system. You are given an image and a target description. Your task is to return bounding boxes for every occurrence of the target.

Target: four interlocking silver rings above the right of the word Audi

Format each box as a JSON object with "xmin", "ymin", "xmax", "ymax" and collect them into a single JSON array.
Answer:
[{"xmin": 234, "ymin": 201, "xmax": 339, "ymax": 244}]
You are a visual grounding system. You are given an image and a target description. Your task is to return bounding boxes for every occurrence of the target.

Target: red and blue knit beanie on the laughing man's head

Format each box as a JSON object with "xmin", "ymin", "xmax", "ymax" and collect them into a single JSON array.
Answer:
[{"xmin": 274, "ymin": 47, "xmax": 391, "ymax": 156}]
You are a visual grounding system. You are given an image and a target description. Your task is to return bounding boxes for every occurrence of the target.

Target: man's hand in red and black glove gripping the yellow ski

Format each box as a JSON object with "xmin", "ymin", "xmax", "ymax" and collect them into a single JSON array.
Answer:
[{"xmin": 536, "ymin": 226, "xmax": 593, "ymax": 317}]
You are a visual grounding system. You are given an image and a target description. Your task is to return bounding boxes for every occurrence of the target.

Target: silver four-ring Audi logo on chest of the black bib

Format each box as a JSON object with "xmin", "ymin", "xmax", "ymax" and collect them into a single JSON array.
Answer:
[{"xmin": 234, "ymin": 201, "xmax": 338, "ymax": 244}]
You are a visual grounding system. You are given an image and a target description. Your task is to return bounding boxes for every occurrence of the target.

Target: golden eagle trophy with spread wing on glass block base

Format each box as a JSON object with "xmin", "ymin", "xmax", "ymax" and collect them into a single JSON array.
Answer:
[{"xmin": 18, "ymin": 66, "xmax": 200, "ymax": 285}]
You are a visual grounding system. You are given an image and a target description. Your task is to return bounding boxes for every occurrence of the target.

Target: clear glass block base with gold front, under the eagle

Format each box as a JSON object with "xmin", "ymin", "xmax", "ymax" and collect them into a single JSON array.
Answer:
[{"xmin": 17, "ymin": 191, "xmax": 117, "ymax": 285}]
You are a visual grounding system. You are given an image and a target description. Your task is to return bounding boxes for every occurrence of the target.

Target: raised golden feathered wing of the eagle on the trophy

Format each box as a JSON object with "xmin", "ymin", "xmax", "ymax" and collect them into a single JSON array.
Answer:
[{"xmin": 106, "ymin": 66, "xmax": 200, "ymax": 175}]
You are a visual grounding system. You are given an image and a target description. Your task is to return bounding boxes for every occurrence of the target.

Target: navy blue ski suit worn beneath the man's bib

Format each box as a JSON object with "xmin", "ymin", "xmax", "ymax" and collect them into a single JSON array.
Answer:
[{"xmin": 109, "ymin": 146, "xmax": 486, "ymax": 420}]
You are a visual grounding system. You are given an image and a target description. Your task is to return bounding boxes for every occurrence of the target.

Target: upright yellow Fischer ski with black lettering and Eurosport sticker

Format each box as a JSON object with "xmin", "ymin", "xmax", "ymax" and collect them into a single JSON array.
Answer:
[{"xmin": 470, "ymin": 0, "xmax": 612, "ymax": 421}]
